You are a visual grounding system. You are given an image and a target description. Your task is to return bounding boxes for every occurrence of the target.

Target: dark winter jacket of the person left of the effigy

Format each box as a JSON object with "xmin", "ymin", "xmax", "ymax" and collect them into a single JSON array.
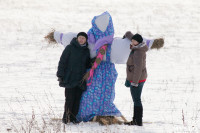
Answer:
[{"xmin": 57, "ymin": 38, "xmax": 91, "ymax": 90}]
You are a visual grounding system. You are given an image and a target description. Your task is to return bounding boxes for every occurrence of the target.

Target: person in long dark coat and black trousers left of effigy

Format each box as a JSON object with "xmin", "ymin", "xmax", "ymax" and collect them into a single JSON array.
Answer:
[{"xmin": 57, "ymin": 32, "xmax": 90, "ymax": 124}]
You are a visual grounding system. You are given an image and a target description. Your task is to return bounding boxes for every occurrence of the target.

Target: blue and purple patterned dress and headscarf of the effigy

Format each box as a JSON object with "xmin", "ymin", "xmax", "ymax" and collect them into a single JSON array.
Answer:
[{"xmin": 76, "ymin": 12, "xmax": 121, "ymax": 122}]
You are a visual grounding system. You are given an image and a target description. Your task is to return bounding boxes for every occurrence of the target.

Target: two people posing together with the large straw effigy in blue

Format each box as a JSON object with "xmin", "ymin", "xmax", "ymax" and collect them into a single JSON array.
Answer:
[{"xmin": 46, "ymin": 12, "xmax": 164, "ymax": 126}]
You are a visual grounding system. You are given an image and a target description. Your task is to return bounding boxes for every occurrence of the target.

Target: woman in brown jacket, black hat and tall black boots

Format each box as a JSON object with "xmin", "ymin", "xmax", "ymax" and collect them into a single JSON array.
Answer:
[{"xmin": 125, "ymin": 34, "xmax": 148, "ymax": 126}]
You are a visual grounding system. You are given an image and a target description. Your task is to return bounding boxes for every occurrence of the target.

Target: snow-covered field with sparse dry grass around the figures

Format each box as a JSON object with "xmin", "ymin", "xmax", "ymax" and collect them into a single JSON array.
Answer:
[{"xmin": 0, "ymin": 0, "xmax": 200, "ymax": 133}]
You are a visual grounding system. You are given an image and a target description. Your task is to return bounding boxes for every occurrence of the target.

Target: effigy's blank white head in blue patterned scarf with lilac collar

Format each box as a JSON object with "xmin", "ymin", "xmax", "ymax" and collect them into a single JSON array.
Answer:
[{"xmin": 87, "ymin": 12, "xmax": 114, "ymax": 50}]
